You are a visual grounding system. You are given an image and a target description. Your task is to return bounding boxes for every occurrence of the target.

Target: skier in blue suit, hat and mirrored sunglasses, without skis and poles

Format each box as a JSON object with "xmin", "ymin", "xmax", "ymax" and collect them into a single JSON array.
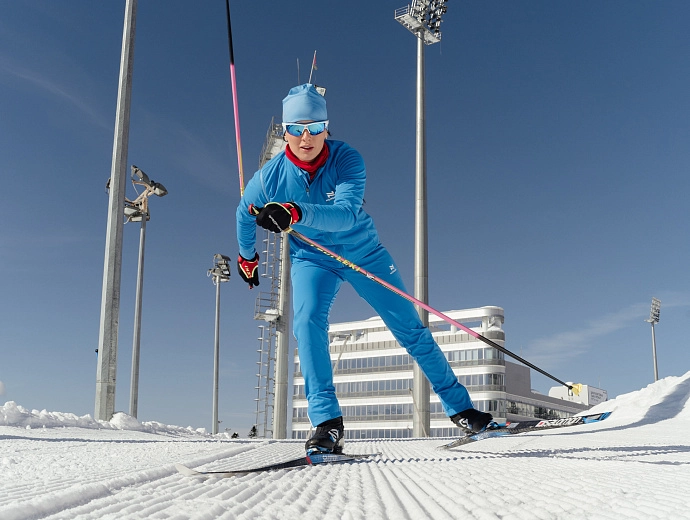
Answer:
[{"xmin": 237, "ymin": 83, "xmax": 492, "ymax": 453}]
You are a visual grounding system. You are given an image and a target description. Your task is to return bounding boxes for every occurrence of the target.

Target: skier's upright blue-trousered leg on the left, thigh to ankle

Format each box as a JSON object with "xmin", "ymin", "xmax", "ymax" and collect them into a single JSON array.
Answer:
[{"xmin": 291, "ymin": 259, "xmax": 342, "ymax": 426}]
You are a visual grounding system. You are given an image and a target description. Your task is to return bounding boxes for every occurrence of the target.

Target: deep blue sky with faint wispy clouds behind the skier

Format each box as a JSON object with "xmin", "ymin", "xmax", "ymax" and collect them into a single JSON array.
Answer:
[{"xmin": 0, "ymin": 0, "xmax": 690, "ymax": 435}]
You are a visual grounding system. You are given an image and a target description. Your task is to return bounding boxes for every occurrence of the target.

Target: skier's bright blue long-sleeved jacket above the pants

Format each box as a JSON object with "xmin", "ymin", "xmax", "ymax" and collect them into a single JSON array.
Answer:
[{"xmin": 237, "ymin": 140, "xmax": 379, "ymax": 258}]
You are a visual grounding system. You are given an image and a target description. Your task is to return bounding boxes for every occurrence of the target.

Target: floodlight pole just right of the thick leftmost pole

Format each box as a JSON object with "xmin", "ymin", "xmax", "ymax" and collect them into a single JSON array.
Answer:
[{"xmin": 125, "ymin": 165, "xmax": 168, "ymax": 417}]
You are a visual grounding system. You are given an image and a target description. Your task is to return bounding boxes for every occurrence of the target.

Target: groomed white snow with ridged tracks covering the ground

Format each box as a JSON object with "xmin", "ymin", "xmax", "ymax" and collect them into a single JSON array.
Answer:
[{"xmin": 0, "ymin": 372, "xmax": 690, "ymax": 520}]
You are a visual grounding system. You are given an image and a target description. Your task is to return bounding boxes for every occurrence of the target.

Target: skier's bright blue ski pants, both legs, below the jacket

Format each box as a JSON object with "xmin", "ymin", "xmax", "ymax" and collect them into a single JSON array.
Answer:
[{"xmin": 291, "ymin": 244, "xmax": 473, "ymax": 426}]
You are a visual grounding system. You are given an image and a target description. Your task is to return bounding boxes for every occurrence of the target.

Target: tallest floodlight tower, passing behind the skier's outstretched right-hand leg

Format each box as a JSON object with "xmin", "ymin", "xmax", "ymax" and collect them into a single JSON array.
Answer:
[{"xmin": 394, "ymin": 0, "xmax": 448, "ymax": 437}]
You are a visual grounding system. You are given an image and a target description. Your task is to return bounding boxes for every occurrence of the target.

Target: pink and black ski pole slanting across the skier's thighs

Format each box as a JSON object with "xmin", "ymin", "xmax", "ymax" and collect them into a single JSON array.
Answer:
[{"xmin": 286, "ymin": 228, "xmax": 579, "ymax": 394}]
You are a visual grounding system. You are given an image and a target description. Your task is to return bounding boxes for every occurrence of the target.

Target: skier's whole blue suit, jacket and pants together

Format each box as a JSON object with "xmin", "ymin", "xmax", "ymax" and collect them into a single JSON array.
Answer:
[{"xmin": 237, "ymin": 139, "xmax": 472, "ymax": 426}]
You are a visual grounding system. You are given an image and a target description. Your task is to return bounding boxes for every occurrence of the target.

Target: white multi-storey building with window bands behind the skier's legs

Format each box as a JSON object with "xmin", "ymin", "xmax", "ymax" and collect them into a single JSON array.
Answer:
[{"xmin": 292, "ymin": 307, "xmax": 606, "ymax": 439}]
